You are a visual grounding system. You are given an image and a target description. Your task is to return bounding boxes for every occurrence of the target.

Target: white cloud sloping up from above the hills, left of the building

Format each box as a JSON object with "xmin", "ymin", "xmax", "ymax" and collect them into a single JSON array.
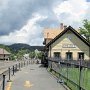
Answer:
[{"xmin": 0, "ymin": 13, "xmax": 47, "ymax": 45}]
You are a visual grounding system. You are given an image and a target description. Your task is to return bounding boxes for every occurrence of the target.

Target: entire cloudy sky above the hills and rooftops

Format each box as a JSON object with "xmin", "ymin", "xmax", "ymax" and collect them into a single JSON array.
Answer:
[{"xmin": 0, "ymin": 0, "xmax": 90, "ymax": 45}]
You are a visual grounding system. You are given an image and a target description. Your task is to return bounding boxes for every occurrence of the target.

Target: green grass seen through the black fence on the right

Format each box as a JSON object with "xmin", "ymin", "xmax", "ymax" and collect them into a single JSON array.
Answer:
[{"xmin": 48, "ymin": 67, "xmax": 90, "ymax": 90}]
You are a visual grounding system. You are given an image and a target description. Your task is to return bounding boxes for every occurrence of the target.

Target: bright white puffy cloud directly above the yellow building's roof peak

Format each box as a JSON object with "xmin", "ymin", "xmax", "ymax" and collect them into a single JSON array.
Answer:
[{"xmin": 53, "ymin": 0, "xmax": 89, "ymax": 26}]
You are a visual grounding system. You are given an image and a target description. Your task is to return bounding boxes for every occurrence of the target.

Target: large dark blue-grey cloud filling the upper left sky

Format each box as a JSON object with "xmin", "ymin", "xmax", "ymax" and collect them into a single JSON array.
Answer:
[{"xmin": 0, "ymin": 0, "xmax": 62, "ymax": 35}]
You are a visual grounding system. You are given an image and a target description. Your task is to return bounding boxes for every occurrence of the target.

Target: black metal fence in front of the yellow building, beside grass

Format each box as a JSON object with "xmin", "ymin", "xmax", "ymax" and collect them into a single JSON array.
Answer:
[{"xmin": 48, "ymin": 58, "xmax": 90, "ymax": 90}]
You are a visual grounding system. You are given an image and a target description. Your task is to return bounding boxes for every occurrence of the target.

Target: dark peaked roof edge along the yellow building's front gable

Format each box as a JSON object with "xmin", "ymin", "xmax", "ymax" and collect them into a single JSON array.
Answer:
[{"xmin": 46, "ymin": 26, "xmax": 90, "ymax": 47}]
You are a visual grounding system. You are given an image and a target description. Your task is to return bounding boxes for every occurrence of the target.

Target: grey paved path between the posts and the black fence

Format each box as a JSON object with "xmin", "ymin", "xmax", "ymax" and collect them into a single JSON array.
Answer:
[{"xmin": 6, "ymin": 64, "xmax": 66, "ymax": 90}]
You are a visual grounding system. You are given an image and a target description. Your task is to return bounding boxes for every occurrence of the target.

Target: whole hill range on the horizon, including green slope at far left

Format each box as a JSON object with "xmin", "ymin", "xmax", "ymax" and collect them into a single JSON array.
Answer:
[{"xmin": 0, "ymin": 43, "xmax": 44, "ymax": 53}]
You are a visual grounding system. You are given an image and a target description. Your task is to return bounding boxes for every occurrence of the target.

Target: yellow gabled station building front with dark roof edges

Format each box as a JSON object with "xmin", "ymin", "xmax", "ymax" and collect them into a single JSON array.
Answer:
[{"xmin": 44, "ymin": 26, "xmax": 90, "ymax": 60}]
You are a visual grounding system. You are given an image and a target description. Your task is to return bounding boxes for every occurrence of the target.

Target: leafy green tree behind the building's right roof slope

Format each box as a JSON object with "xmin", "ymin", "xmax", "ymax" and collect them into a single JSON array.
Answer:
[{"xmin": 79, "ymin": 19, "xmax": 90, "ymax": 42}]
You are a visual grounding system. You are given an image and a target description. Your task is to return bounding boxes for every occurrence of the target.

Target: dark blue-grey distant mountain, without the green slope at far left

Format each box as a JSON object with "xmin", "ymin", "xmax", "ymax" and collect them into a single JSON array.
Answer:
[{"xmin": 8, "ymin": 43, "xmax": 44, "ymax": 53}]
